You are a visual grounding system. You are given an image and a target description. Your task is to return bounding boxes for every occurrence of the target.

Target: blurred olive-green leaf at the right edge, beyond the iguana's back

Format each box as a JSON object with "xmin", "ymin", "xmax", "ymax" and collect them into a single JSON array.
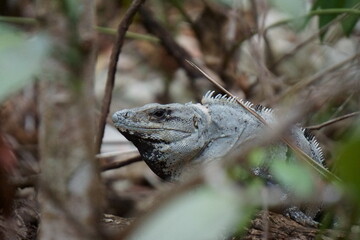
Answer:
[{"xmin": 335, "ymin": 124, "xmax": 360, "ymax": 201}]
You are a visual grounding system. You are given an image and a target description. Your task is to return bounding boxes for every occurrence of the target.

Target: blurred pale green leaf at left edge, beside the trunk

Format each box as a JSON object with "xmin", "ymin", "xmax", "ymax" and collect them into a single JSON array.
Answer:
[{"xmin": 0, "ymin": 25, "xmax": 50, "ymax": 101}]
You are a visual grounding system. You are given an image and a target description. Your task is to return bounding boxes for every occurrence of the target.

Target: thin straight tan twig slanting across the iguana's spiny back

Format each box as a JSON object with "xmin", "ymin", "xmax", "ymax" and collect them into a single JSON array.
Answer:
[{"xmin": 185, "ymin": 60, "xmax": 341, "ymax": 182}]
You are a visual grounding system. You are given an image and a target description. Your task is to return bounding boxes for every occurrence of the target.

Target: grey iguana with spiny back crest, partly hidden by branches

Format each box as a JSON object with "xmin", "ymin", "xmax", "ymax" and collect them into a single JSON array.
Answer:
[{"xmin": 112, "ymin": 89, "xmax": 323, "ymax": 225}]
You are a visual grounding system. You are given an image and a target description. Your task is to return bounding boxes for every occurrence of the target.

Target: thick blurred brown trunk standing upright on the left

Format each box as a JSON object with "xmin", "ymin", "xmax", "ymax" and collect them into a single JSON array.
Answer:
[{"xmin": 37, "ymin": 0, "xmax": 102, "ymax": 240}]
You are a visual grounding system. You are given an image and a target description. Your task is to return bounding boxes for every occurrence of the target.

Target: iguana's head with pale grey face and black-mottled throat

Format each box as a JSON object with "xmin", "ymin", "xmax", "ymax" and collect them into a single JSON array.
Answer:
[{"xmin": 112, "ymin": 103, "xmax": 208, "ymax": 179}]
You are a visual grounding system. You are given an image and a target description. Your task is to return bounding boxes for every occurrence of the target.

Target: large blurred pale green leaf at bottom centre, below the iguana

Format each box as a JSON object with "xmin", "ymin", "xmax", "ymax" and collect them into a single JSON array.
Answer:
[{"xmin": 129, "ymin": 187, "xmax": 249, "ymax": 240}]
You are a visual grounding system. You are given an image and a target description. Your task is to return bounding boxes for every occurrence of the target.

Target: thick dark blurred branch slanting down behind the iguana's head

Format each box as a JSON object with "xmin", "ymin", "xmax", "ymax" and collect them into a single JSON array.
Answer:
[{"xmin": 139, "ymin": 6, "xmax": 202, "ymax": 79}]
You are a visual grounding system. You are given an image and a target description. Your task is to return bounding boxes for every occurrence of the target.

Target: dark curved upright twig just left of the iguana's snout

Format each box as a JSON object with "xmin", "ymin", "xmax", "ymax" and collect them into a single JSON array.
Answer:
[{"xmin": 96, "ymin": 0, "xmax": 145, "ymax": 152}]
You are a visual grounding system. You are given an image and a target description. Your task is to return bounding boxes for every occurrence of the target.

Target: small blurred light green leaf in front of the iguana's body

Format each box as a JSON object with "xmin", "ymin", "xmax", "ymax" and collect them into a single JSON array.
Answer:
[{"xmin": 270, "ymin": 158, "xmax": 314, "ymax": 198}]
